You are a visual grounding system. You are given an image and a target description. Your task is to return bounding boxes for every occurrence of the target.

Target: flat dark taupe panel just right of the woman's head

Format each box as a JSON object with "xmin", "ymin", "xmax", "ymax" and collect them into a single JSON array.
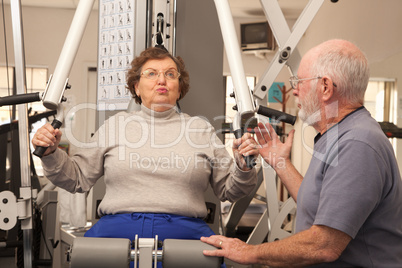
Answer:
[{"xmin": 176, "ymin": 0, "xmax": 225, "ymax": 141}]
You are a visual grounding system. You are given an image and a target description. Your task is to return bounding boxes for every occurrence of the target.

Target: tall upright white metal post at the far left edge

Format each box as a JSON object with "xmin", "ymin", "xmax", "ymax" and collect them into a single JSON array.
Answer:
[{"xmin": 10, "ymin": 0, "xmax": 32, "ymax": 268}]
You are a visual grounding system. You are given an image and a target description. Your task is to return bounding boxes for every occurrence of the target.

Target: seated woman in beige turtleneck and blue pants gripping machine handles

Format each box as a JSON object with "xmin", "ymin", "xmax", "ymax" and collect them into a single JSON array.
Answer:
[{"xmin": 32, "ymin": 48, "xmax": 258, "ymax": 266}]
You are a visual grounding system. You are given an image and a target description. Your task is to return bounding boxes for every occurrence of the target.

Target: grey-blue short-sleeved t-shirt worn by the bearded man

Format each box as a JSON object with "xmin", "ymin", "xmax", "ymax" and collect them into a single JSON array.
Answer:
[{"xmin": 296, "ymin": 107, "xmax": 402, "ymax": 267}]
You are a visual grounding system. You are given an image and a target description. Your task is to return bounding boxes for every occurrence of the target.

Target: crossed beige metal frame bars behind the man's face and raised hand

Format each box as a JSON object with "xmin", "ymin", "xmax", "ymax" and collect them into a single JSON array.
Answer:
[{"xmin": 253, "ymin": 0, "xmax": 324, "ymax": 244}]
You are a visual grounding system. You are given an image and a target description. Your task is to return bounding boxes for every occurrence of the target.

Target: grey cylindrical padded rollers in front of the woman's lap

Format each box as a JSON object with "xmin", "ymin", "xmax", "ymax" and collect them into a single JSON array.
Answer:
[{"xmin": 68, "ymin": 236, "xmax": 222, "ymax": 268}]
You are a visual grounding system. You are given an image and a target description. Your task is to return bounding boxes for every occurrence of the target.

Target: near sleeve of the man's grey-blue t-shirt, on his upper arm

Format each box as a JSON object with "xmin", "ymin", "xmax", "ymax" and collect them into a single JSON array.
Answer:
[{"xmin": 314, "ymin": 140, "xmax": 385, "ymax": 238}]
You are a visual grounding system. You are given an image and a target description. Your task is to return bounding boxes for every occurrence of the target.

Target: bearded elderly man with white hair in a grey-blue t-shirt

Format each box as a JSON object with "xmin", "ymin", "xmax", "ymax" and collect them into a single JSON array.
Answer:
[{"xmin": 201, "ymin": 40, "xmax": 402, "ymax": 267}]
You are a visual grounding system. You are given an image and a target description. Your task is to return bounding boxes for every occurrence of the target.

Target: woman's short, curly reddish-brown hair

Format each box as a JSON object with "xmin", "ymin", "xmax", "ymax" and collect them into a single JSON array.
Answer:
[{"xmin": 126, "ymin": 47, "xmax": 190, "ymax": 104}]
